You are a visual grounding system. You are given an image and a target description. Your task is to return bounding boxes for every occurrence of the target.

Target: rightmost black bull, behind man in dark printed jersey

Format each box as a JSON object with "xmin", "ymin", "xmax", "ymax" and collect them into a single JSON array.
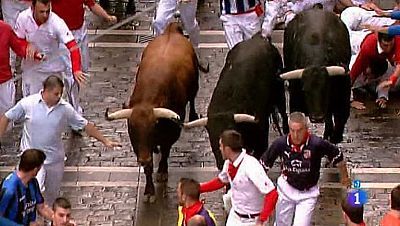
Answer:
[{"xmin": 281, "ymin": 9, "xmax": 351, "ymax": 143}]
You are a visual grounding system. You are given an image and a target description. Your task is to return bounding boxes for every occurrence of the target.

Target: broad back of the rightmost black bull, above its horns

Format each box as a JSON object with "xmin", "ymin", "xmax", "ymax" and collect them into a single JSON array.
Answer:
[{"xmin": 283, "ymin": 9, "xmax": 351, "ymax": 70}]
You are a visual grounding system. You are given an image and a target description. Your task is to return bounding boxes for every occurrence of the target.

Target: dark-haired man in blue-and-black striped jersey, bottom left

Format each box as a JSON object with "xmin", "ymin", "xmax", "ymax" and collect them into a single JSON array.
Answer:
[{"xmin": 0, "ymin": 149, "xmax": 53, "ymax": 226}]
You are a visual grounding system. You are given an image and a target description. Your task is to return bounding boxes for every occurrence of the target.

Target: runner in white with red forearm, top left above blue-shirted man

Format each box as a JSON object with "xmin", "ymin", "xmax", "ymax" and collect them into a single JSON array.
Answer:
[{"xmin": 15, "ymin": 0, "xmax": 86, "ymax": 100}]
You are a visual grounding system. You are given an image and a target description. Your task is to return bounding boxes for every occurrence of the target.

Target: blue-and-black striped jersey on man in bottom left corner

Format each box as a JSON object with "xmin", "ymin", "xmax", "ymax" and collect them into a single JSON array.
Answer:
[{"xmin": 0, "ymin": 172, "xmax": 44, "ymax": 225}]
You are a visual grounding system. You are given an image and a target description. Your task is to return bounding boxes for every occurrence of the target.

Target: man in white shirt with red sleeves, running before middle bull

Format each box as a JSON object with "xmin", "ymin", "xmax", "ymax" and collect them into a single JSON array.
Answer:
[{"xmin": 200, "ymin": 130, "xmax": 278, "ymax": 226}]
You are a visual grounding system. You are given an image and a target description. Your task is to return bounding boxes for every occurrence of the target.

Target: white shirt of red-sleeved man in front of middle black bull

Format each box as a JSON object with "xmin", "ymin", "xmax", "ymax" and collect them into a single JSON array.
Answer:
[{"xmin": 218, "ymin": 150, "xmax": 275, "ymax": 214}]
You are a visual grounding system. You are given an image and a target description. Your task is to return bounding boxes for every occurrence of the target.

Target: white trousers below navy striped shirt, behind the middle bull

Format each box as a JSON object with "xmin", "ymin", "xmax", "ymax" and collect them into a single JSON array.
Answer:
[{"xmin": 220, "ymin": 12, "xmax": 261, "ymax": 49}]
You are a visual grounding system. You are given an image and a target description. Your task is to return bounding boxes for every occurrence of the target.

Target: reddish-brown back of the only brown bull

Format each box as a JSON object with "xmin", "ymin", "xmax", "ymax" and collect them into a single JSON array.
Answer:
[{"xmin": 130, "ymin": 23, "xmax": 198, "ymax": 113}]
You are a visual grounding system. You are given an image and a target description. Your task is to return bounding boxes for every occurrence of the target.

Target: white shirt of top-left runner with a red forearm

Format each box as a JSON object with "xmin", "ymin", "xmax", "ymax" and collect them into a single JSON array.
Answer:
[{"xmin": 14, "ymin": 7, "xmax": 74, "ymax": 72}]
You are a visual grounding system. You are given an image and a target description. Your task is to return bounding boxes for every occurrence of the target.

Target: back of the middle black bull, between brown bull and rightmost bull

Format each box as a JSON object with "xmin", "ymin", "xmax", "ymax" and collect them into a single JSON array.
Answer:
[{"xmin": 208, "ymin": 33, "xmax": 282, "ymax": 115}]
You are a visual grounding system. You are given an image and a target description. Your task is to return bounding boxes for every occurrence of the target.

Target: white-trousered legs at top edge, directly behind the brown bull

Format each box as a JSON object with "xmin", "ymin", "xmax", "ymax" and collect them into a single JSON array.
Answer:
[{"xmin": 153, "ymin": 0, "xmax": 200, "ymax": 48}]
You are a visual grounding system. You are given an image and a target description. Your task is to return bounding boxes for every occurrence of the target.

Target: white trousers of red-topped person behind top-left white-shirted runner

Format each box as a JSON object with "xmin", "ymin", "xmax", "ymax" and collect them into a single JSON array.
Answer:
[{"xmin": 60, "ymin": 23, "xmax": 90, "ymax": 114}]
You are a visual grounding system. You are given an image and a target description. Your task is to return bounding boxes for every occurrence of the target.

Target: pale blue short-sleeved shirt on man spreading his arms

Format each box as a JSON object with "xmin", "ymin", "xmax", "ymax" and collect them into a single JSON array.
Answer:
[{"xmin": 5, "ymin": 92, "xmax": 87, "ymax": 164}]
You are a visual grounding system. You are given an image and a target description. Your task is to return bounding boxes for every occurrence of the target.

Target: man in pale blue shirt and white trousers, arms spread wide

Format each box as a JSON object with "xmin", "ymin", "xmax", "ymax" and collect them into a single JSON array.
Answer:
[{"xmin": 0, "ymin": 75, "xmax": 120, "ymax": 206}]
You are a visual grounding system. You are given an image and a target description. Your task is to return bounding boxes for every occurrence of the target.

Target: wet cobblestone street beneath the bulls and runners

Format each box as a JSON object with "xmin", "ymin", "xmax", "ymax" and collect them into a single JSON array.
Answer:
[{"xmin": 0, "ymin": 0, "xmax": 400, "ymax": 226}]
